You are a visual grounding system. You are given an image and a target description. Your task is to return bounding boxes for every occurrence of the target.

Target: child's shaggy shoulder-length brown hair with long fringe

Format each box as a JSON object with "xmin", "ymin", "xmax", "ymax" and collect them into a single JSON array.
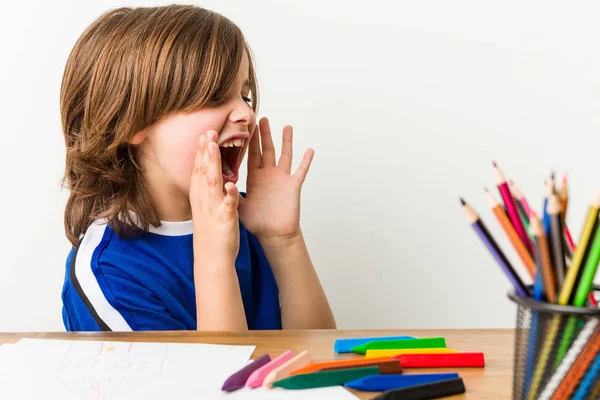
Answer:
[{"xmin": 60, "ymin": 5, "xmax": 258, "ymax": 246}]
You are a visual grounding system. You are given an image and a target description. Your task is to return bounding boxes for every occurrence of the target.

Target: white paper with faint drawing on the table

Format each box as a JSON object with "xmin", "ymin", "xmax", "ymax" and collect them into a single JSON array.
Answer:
[{"xmin": 0, "ymin": 339, "xmax": 356, "ymax": 400}]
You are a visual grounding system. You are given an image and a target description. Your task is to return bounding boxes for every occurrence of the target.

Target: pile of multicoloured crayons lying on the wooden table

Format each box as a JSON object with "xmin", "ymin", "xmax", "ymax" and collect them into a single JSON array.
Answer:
[{"xmin": 222, "ymin": 336, "xmax": 485, "ymax": 400}]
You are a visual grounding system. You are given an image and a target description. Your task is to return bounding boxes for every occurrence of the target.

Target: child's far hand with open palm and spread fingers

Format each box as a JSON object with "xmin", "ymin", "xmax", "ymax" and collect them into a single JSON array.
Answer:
[{"xmin": 239, "ymin": 118, "xmax": 314, "ymax": 246}]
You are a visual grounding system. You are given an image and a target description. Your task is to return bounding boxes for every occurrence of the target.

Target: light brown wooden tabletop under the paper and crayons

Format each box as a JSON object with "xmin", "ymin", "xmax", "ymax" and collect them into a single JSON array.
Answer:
[{"xmin": 0, "ymin": 329, "xmax": 514, "ymax": 400}]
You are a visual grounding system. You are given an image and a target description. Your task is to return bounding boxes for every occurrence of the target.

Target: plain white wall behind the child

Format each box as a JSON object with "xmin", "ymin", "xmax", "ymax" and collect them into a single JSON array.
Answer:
[{"xmin": 0, "ymin": 0, "xmax": 600, "ymax": 331}]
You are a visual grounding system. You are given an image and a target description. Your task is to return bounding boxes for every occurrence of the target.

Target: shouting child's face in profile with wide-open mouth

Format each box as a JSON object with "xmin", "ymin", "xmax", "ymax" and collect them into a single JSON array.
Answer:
[{"xmin": 133, "ymin": 54, "xmax": 256, "ymax": 202}]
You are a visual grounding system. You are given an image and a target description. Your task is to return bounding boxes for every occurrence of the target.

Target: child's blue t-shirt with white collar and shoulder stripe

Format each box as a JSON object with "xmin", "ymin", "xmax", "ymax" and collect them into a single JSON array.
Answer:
[{"xmin": 62, "ymin": 212, "xmax": 281, "ymax": 331}]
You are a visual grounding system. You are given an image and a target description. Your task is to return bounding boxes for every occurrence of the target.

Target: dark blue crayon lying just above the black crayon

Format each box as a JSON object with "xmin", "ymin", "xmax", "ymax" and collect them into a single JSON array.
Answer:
[{"xmin": 344, "ymin": 372, "xmax": 459, "ymax": 392}]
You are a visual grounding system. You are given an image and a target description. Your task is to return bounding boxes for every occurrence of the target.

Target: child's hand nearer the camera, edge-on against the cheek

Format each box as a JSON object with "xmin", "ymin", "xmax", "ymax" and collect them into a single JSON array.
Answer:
[{"xmin": 190, "ymin": 131, "xmax": 240, "ymax": 268}]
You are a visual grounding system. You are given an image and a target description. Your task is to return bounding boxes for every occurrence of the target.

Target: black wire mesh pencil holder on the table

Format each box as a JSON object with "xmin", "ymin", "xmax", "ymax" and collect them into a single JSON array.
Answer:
[{"xmin": 508, "ymin": 286, "xmax": 600, "ymax": 400}]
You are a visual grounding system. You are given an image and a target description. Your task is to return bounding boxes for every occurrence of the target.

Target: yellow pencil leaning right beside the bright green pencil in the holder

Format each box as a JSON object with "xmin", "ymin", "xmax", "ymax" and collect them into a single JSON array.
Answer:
[{"xmin": 558, "ymin": 189, "xmax": 600, "ymax": 305}]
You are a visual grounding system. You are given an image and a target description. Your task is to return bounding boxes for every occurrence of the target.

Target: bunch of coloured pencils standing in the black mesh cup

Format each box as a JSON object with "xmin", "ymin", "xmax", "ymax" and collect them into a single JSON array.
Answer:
[{"xmin": 460, "ymin": 163, "xmax": 600, "ymax": 400}]
